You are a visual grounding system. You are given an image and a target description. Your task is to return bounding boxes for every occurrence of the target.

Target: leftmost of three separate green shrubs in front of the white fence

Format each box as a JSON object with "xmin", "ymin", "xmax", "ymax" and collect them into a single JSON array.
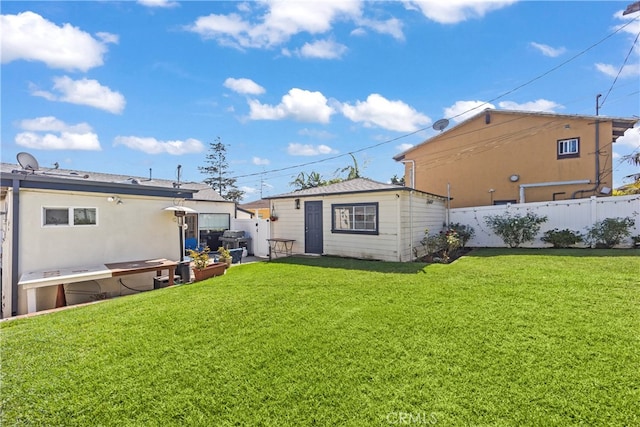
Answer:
[{"xmin": 484, "ymin": 212, "xmax": 547, "ymax": 248}]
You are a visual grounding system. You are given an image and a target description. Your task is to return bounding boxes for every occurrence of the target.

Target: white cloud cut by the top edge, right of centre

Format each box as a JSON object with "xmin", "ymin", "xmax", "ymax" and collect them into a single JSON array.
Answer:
[{"xmin": 402, "ymin": 0, "xmax": 516, "ymax": 24}]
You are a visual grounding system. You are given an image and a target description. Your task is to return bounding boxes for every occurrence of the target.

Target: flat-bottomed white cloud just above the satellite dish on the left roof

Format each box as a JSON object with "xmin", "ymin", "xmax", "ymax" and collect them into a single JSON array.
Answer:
[{"xmin": 15, "ymin": 116, "xmax": 102, "ymax": 151}]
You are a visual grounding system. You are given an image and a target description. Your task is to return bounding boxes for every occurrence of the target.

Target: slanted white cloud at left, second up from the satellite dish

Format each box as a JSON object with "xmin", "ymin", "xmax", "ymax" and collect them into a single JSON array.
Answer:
[{"xmin": 31, "ymin": 76, "xmax": 126, "ymax": 114}]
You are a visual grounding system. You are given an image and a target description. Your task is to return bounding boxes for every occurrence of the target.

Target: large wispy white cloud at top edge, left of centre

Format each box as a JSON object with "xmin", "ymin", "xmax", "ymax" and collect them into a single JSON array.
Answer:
[{"xmin": 186, "ymin": 0, "xmax": 362, "ymax": 48}]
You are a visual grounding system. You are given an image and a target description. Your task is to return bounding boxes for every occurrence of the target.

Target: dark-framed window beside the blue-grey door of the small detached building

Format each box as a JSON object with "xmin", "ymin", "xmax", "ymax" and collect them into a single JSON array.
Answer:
[{"xmin": 331, "ymin": 203, "xmax": 378, "ymax": 234}]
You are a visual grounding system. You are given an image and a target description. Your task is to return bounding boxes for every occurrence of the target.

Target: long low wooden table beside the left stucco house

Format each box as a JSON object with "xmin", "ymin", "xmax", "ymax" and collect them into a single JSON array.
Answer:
[{"xmin": 18, "ymin": 258, "xmax": 178, "ymax": 313}]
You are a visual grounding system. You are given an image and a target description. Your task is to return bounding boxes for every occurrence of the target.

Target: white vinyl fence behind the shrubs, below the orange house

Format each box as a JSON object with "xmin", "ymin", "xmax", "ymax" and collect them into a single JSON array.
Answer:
[{"xmin": 449, "ymin": 195, "xmax": 640, "ymax": 248}]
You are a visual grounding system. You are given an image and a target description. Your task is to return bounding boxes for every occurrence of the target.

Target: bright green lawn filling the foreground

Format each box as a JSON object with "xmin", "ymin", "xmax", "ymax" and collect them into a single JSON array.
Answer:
[{"xmin": 0, "ymin": 249, "xmax": 640, "ymax": 426}]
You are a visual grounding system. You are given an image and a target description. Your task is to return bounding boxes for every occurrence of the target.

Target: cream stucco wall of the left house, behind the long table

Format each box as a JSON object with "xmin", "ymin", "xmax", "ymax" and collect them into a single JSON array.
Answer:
[{"xmin": 10, "ymin": 188, "xmax": 185, "ymax": 314}]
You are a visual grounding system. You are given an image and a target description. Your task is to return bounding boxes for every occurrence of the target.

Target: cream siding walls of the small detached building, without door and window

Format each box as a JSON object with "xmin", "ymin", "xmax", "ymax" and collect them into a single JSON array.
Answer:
[{"xmin": 271, "ymin": 191, "xmax": 445, "ymax": 261}]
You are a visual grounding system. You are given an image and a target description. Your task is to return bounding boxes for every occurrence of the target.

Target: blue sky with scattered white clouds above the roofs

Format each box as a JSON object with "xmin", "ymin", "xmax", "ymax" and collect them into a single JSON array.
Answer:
[{"xmin": 1, "ymin": 0, "xmax": 640, "ymax": 201}]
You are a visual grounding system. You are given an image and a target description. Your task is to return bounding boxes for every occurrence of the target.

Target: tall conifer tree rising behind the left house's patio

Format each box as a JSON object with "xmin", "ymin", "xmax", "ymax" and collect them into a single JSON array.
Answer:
[{"xmin": 198, "ymin": 137, "xmax": 244, "ymax": 202}]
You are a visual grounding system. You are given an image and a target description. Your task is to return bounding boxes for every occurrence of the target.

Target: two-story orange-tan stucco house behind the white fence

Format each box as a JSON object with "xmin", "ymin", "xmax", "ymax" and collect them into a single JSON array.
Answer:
[{"xmin": 394, "ymin": 109, "xmax": 637, "ymax": 208}]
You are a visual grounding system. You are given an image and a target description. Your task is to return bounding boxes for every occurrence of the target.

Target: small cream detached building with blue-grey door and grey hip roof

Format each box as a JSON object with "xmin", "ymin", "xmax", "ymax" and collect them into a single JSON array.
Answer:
[{"xmin": 267, "ymin": 178, "xmax": 447, "ymax": 261}]
